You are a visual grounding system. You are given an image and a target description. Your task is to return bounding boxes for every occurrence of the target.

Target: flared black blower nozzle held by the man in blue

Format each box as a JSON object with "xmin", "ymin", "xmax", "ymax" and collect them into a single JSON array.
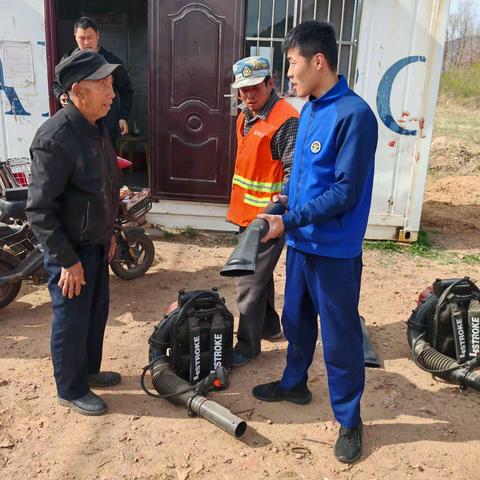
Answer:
[{"xmin": 220, "ymin": 202, "xmax": 285, "ymax": 277}]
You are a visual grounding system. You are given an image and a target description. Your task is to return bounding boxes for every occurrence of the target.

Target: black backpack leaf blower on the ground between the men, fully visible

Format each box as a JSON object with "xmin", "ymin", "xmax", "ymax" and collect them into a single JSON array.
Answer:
[{"xmin": 140, "ymin": 289, "xmax": 247, "ymax": 438}]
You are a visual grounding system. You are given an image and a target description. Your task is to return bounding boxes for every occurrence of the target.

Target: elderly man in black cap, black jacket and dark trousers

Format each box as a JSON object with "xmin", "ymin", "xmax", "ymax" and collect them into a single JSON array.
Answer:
[{"xmin": 27, "ymin": 50, "xmax": 122, "ymax": 415}]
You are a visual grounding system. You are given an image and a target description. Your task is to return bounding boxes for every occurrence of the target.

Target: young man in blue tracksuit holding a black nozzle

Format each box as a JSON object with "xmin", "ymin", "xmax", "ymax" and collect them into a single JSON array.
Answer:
[{"xmin": 252, "ymin": 21, "xmax": 378, "ymax": 463}]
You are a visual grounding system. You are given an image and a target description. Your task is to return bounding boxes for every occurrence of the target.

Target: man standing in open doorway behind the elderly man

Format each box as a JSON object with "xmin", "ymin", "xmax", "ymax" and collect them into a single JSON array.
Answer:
[{"xmin": 53, "ymin": 17, "xmax": 133, "ymax": 147}]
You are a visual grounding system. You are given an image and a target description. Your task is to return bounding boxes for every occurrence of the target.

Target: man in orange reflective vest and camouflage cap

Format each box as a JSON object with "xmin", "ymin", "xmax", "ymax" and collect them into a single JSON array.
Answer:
[{"xmin": 227, "ymin": 56, "xmax": 298, "ymax": 367}]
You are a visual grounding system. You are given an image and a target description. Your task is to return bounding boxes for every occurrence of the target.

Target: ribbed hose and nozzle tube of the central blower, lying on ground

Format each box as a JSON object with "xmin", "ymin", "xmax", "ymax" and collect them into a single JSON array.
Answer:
[{"xmin": 150, "ymin": 357, "xmax": 247, "ymax": 438}]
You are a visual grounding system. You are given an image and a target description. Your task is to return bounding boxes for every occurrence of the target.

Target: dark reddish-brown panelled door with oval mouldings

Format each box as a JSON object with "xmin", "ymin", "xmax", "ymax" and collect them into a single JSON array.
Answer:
[{"xmin": 149, "ymin": 0, "xmax": 244, "ymax": 202}]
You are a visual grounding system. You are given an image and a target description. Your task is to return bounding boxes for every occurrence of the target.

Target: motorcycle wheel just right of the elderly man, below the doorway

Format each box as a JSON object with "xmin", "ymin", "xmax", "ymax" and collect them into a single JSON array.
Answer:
[{"xmin": 110, "ymin": 232, "xmax": 155, "ymax": 280}]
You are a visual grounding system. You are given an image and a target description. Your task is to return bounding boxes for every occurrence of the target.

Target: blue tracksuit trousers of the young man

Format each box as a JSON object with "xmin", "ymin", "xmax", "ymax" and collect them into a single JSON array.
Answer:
[{"xmin": 280, "ymin": 247, "xmax": 365, "ymax": 428}]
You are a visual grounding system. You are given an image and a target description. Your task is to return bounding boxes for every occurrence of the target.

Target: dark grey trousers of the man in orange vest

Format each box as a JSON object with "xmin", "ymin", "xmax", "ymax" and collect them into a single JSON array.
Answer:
[{"xmin": 235, "ymin": 237, "xmax": 285, "ymax": 358}]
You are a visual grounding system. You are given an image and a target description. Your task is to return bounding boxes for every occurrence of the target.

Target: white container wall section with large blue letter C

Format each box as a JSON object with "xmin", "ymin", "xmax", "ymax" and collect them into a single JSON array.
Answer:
[{"xmin": 355, "ymin": 0, "xmax": 450, "ymax": 241}]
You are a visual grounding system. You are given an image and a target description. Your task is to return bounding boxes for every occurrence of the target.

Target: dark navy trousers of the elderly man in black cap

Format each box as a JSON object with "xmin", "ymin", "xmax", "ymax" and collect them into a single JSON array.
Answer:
[{"xmin": 45, "ymin": 245, "xmax": 109, "ymax": 400}]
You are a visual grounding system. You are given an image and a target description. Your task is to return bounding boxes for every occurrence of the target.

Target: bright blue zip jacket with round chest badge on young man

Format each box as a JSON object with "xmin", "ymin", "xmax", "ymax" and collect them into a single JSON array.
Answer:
[{"xmin": 282, "ymin": 76, "xmax": 378, "ymax": 258}]
